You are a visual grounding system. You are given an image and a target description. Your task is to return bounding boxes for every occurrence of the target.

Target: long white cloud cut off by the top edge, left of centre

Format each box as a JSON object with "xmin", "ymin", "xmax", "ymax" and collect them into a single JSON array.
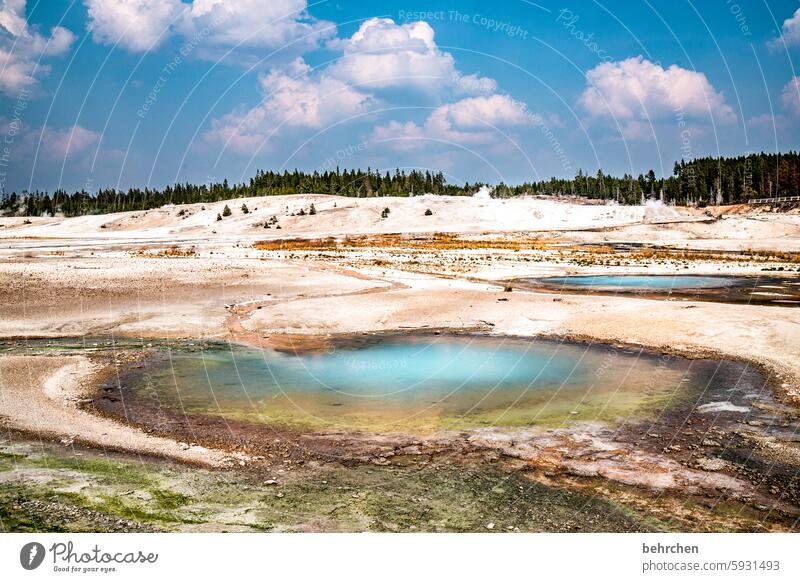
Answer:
[{"xmin": 84, "ymin": 0, "xmax": 335, "ymax": 58}]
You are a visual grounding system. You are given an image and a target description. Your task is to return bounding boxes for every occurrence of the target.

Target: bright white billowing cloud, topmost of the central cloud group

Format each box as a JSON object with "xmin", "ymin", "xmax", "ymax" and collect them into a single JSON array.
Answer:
[{"xmin": 328, "ymin": 18, "xmax": 497, "ymax": 95}]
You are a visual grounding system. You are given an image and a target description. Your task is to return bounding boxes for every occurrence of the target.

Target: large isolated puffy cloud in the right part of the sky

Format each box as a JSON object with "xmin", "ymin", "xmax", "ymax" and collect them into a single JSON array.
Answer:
[{"xmin": 579, "ymin": 56, "xmax": 736, "ymax": 137}]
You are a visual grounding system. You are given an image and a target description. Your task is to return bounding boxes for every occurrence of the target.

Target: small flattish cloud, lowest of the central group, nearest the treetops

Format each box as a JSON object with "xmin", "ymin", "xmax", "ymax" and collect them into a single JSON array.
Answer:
[{"xmin": 372, "ymin": 95, "xmax": 540, "ymax": 150}]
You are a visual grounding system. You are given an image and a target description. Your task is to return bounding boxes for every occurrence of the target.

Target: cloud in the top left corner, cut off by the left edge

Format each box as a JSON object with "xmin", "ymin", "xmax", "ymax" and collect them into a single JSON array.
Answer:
[{"xmin": 0, "ymin": 0, "xmax": 75, "ymax": 95}]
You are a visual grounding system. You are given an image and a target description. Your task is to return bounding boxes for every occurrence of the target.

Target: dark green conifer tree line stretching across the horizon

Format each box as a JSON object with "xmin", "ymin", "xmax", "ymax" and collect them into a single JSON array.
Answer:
[{"xmin": 0, "ymin": 151, "xmax": 800, "ymax": 216}]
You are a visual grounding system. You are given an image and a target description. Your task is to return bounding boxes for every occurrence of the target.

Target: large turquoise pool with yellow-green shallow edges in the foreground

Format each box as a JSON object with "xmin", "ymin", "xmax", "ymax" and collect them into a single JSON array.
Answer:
[{"xmin": 125, "ymin": 336, "xmax": 756, "ymax": 432}]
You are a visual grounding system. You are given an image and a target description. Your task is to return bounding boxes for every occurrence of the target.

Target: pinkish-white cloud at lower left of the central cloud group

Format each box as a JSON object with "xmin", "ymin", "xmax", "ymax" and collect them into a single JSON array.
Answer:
[{"xmin": 205, "ymin": 59, "xmax": 374, "ymax": 153}]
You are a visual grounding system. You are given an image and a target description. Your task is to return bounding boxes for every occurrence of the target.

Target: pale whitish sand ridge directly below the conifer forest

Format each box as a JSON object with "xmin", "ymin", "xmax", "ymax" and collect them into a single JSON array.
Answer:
[{"xmin": 0, "ymin": 194, "xmax": 800, "ymax": 251}]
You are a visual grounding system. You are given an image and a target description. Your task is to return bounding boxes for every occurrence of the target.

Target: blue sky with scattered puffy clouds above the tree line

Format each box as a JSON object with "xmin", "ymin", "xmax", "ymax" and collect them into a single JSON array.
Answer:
[{"xmin": 0, "ymin": 0, "xmax": 800, "ymax": 192}]
